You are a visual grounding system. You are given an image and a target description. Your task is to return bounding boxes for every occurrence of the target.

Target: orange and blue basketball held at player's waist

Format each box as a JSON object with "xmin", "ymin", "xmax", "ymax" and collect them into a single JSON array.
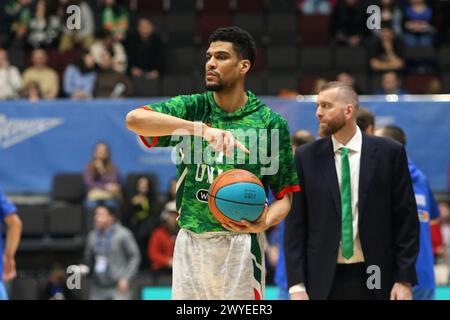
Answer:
[{"xmin": 208, "ymin": 169, "xmax": 266, "ymax": 225}]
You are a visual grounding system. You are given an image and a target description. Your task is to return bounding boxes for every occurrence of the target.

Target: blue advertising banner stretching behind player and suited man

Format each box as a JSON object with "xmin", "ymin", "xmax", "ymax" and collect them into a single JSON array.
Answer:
[{"xmin": 0, "ymin": 97, "xmax": 450, "ymax": 193}]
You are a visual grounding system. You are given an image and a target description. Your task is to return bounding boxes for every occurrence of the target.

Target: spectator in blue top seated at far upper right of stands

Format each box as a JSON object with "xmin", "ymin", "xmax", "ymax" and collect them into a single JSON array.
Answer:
[{"xmin": 403, "ymin": 0, "xmax": 435, "ymax": 47}]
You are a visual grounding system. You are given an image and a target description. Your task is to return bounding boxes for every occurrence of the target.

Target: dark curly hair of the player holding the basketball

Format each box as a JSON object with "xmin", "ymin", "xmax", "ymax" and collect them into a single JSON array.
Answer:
[{"xmin": 208, "ymin": 26, "xmax": 256, "ymax": 65}]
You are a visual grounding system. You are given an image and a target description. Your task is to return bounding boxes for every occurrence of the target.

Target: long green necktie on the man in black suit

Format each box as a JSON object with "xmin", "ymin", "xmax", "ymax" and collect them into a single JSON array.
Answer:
[{"xmin": 341, "ymin": 147, "xmax": 353, "ymax": 259}]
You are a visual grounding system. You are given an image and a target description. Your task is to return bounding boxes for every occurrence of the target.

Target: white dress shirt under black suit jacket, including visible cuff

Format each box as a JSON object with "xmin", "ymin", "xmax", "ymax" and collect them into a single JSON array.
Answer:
[{"xmin": 289, "ymin": 127, "xmax": 364, "ymax": 294}]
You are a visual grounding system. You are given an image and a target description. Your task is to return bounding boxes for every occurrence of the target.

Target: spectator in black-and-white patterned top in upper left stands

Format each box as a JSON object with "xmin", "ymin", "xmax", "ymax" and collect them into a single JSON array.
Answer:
[{"xmin": 27, "ymin": 0, "xmax": 63, "ymax": 48}]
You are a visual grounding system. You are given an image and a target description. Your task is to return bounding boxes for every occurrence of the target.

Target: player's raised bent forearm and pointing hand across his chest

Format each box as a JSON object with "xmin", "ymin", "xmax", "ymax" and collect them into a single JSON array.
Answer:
[{"xmin": 125, "ymin": 108, "xmax": 249, "ymax": 153}]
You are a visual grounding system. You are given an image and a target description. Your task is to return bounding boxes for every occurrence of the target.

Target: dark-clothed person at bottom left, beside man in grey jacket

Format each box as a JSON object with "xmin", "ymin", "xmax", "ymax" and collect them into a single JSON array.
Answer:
[{"xmin": 40, "ymin": 264, "xmax": 72, "ymax": 300}]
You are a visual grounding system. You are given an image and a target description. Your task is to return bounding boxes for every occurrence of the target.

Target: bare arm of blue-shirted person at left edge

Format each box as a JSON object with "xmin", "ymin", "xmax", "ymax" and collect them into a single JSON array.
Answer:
[{"xmin": 3, "ymin": 213, "xmax": 22, "ymax": 280}]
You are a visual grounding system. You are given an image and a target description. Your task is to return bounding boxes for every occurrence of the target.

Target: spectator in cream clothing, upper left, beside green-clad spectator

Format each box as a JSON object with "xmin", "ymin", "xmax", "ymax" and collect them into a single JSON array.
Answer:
[{"xmin": 59, "ymin": 0, "xmax": 95, "ymax": 52}]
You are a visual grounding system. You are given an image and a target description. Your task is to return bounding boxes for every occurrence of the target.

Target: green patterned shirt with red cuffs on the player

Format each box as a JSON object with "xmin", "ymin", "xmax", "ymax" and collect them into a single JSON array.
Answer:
[{"xmin": 141, "ymin": 91, "xmax": 300, "ymax": 233}]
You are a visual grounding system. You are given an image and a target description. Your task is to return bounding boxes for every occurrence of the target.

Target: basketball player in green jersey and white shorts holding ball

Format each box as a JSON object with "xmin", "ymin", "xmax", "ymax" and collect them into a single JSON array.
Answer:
[{"xmin": 126, "ymin": 27, "xmax": 300, "ymax": 300}]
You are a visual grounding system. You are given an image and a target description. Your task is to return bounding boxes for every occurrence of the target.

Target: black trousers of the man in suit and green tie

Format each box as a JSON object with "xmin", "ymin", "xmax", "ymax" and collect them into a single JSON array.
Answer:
[{"xmin": 328, "ymin": 263, "xmax": 375, "ymax": 300}]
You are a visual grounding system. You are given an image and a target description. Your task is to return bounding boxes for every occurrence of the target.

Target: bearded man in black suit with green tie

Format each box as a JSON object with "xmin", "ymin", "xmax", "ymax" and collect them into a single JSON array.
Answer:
[{"xmin": 285, "ymin": 82, "xmax": 419, "ymax": 300}]
